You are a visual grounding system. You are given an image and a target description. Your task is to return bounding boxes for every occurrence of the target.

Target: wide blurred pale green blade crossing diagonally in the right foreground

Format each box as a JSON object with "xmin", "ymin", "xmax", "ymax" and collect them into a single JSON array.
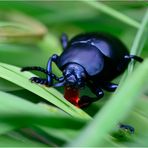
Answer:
[{"xmin": 68, "ymin": 59, "xmax": 148, "ymax": 147}]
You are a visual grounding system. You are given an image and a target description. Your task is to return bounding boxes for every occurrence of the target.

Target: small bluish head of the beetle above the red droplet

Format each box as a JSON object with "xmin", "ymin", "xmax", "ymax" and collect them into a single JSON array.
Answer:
[{"xmin": 63, "ymin": 63, "xmax": 86, "ymax": 88}]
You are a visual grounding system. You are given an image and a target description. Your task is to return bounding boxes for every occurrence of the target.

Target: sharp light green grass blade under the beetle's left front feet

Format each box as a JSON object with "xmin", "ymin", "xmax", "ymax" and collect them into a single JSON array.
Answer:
[{"xmin": 0, "ymin": 63, "xmax": 90, "ymax": 119}]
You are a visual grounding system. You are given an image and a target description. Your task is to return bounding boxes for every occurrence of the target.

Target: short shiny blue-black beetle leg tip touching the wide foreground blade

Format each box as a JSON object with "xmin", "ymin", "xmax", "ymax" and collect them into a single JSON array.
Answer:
[{"xmin": 101, "ymin": 82, "xmax": 118, "ymax": 92}]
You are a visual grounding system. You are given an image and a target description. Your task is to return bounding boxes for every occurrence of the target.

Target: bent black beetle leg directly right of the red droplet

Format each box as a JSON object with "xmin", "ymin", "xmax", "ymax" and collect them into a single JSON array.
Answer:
[{"xmin": 78, "ymin": 83, "xmax": 104, "ymax": 108}]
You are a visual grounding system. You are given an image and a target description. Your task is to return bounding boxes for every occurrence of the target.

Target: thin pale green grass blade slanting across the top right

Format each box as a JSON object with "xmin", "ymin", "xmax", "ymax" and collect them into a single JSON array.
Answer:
[{"xmin": 83, "ymin": 0, "xmax": 140, "ymax": 28}]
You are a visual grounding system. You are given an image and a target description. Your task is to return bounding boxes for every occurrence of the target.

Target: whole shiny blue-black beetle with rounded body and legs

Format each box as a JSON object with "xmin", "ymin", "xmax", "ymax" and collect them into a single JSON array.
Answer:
[{"xmin": 21, "ymin": 33, "xmax": 142, "ymax": 107}]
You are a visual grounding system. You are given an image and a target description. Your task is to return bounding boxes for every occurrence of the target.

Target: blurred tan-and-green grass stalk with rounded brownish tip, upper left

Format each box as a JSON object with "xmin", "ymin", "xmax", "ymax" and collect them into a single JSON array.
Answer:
[{"xmin": 0, "ymin": 11, "xmax": 47, "ymax": 43}]
